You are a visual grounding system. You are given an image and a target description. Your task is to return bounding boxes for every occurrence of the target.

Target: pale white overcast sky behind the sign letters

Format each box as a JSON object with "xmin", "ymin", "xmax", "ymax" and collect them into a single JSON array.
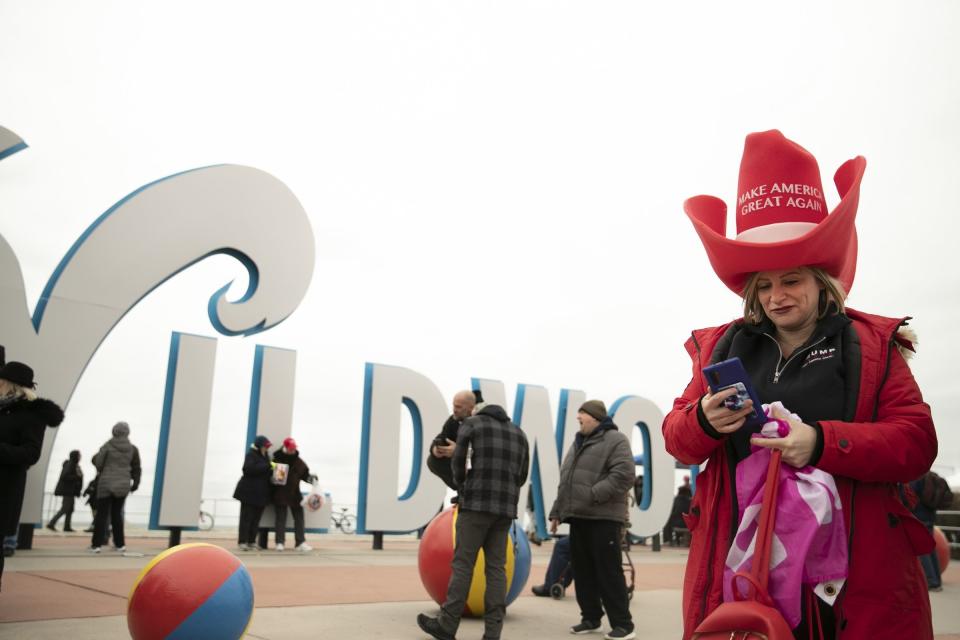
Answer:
[{"xmin": 0, "ymin": 0, "xmax": 960, "ymax": 516}]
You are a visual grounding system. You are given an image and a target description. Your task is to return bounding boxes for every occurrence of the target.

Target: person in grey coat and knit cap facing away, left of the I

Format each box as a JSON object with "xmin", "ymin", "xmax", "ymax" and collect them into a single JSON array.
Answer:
[{"xmin": 90, "ymin": 422, "xmax": 140, "ymax": 553}]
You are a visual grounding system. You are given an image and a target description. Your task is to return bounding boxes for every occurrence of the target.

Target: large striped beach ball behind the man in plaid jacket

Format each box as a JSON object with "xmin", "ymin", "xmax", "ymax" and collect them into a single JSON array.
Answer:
[{"xmin": 417, "ymin": 507, "xmax": 530, "ymax": 616}]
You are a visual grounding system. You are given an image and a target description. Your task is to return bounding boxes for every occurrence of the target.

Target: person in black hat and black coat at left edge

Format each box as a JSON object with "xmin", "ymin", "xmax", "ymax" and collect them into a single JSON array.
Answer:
[{"xmin": 0, "ymin": 362, "xmax": 63, "ymax": 592}]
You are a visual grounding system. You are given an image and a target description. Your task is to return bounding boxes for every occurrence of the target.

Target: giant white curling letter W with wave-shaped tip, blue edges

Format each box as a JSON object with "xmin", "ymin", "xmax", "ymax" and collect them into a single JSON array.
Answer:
[{"xmin": 0, "ymin": 127, "xmax": 314, "ymax": 522}]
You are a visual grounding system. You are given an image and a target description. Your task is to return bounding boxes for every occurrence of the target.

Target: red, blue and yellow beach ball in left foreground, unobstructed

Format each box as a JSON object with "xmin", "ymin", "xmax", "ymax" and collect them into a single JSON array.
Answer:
[{"xmin": 127, "ymin": 543, "xmax": 253, "ymax": 640}]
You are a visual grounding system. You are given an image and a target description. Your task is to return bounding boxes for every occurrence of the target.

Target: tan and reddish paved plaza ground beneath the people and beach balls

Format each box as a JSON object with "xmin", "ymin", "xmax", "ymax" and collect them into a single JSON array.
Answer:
[{"xmin": 0, "ymin": 531, "xmax": 960, "ymax": 640}]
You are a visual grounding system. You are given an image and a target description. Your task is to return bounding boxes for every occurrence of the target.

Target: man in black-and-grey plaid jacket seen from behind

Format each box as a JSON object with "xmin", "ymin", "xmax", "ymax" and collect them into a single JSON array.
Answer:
[{"xmin": 417, "ymin": 404, "xmax": 530, "ymax": 640}]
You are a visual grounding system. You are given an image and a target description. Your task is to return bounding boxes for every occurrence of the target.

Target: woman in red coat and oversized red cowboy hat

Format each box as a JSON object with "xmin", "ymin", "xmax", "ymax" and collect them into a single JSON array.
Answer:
[{"xmin": 663, "ymin": 131, "xmax": 937, "ymax": 640}]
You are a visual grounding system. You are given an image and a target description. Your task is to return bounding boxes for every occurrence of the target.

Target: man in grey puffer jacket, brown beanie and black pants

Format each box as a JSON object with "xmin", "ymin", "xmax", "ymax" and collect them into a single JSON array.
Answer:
[{"xmin": 550, "ymin": 400, "xmax": 636, "ymax": 640}]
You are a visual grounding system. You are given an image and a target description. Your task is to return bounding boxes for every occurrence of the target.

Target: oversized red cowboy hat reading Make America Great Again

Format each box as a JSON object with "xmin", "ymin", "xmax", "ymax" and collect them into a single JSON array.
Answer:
[{"xmin": 683, "ymin": 129, "xmax": 867, "ymax": 295}]
